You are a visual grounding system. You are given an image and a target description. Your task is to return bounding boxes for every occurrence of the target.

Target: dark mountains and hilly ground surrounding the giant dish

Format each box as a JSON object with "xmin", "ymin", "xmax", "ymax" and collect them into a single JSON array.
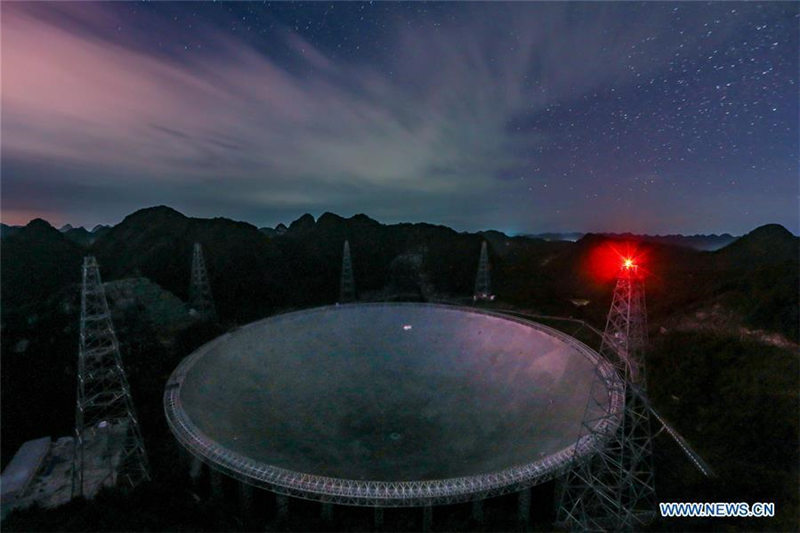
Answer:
[{"xmin": 0, "ymin": 206, "xmax": 800, "ymax": 531}]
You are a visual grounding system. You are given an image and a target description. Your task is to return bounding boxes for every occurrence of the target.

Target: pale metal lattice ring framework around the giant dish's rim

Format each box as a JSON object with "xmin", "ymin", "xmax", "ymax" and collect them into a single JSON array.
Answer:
[{"xmin": 164, "ymin": 303, "xmax": 623, "ymax": 507}]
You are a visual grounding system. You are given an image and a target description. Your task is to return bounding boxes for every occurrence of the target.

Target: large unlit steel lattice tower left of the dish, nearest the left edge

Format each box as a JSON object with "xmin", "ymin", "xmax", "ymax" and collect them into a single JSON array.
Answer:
[{"xmin": 72, "ymin": 256, "xmax": 150, "ymax": 497}]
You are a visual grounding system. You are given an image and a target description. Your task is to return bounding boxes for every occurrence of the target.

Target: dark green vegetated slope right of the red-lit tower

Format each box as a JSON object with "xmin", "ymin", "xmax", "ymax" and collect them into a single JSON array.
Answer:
[{"xmin": 648, "ymin": 332, "xmax": 800, "ymax": 531}]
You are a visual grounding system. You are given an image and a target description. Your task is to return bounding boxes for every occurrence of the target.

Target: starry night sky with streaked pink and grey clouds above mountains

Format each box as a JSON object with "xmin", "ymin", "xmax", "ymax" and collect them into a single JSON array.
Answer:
[{"xmin": 2, "ymin": 2, "xmax": 800, "ymax": 234}]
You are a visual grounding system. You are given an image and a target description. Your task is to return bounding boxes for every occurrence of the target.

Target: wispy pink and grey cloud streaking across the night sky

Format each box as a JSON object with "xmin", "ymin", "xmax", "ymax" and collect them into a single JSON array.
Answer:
[{"xmin": 2, "ymin": 3, "xmax": 764, "ymax": 229}]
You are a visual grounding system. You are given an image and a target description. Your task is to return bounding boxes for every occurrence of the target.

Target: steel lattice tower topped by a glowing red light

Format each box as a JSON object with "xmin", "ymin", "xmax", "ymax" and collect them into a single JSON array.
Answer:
[{"xmin": 557, "ymin": 260, "xmax": 656, "ymax": 531}]
